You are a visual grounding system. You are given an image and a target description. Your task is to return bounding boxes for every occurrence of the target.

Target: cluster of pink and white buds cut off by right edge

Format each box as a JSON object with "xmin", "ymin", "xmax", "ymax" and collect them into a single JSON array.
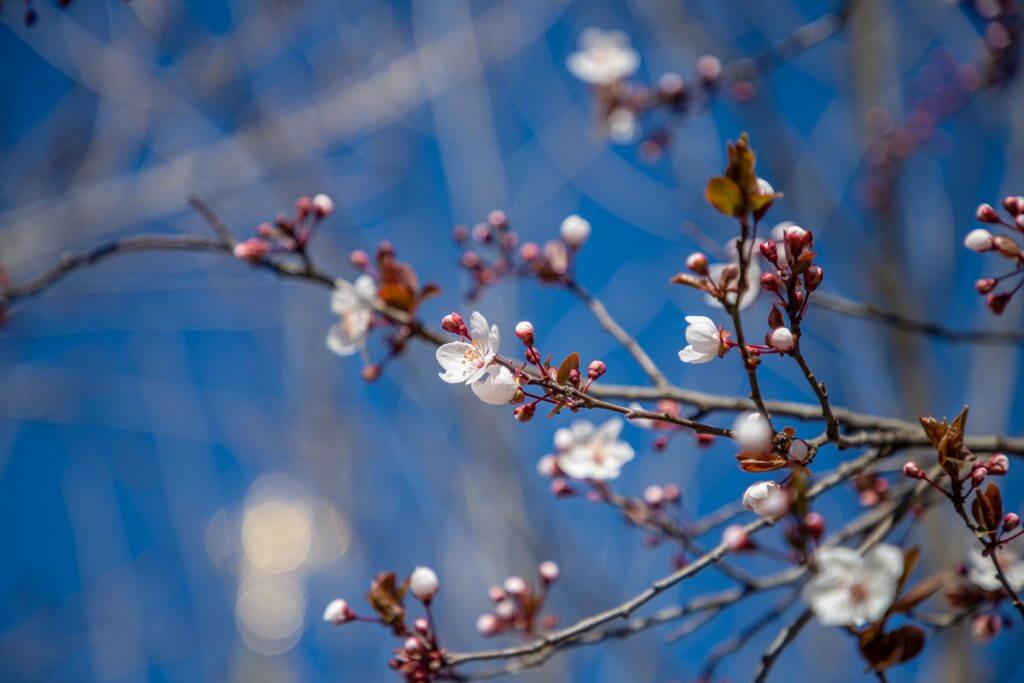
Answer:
[{"xmin": 964, "ymin": 196, "xmax": 1024, "ymax": 315}]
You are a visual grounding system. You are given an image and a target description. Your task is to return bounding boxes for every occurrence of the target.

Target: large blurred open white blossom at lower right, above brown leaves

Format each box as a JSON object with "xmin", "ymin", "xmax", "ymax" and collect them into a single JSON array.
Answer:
[{"xmin": 802, "ymin": 544, "xmax": 903, "ymax": 627}]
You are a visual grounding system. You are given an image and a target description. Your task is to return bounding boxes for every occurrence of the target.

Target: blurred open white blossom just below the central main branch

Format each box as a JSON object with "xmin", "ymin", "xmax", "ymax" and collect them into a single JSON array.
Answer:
[{"xmin": 555, "ymin": 418, "xmax": 634, "ymax": 481}]
